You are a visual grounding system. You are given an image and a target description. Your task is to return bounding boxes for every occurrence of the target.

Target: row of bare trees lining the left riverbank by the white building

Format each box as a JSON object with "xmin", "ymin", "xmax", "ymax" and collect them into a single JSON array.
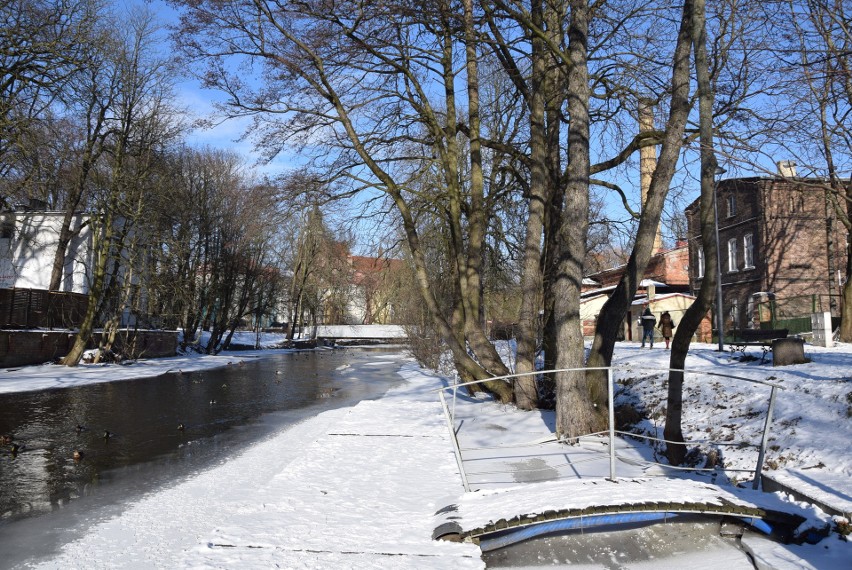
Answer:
[{"xmin": 0, "ymin": 0, "xmax": 312, "ymax": 365}]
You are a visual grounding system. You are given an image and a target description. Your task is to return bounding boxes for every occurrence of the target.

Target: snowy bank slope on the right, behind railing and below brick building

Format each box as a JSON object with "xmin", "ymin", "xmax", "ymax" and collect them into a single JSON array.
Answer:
[{"xmin": 613, "ymin": 343, "xmax": 852, "ymax": 513}]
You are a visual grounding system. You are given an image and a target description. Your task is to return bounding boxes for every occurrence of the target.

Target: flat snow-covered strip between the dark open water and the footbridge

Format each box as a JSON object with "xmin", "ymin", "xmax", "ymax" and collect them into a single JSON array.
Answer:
[{"xmin": 10, "ymin": 353, "xmax": 482, "ymax": 569}]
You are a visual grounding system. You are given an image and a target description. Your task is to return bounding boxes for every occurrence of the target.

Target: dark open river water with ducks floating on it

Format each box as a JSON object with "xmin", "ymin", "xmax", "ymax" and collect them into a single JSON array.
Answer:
[{"xmin": 0, "ymin": 348, "xmax": 401, "ymax": 567}]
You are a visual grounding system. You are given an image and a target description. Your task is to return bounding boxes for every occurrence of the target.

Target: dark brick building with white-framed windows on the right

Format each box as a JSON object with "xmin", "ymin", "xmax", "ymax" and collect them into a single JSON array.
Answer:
[{"xmin": 686, "ymin": 173, "xmax": 848, "ymax": 334}]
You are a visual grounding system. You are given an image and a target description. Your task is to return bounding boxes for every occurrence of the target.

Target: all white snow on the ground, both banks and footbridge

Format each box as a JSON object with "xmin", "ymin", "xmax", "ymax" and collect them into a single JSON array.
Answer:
[{"xmin": 0, "ymin": 336, "xmax": 852, "ymax": 570}]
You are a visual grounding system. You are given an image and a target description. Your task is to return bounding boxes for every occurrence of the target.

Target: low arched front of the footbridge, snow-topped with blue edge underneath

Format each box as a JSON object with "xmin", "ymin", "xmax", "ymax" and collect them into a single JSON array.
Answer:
[{"xmin": 433, "ymin": 478, "xmax": 824, "ymax": 552}]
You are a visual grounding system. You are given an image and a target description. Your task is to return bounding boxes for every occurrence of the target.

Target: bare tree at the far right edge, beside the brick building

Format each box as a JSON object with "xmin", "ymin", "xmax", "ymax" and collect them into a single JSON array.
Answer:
[{"xmin": 771, "ymin": 0, "xmax": 852, "ymax": 342}]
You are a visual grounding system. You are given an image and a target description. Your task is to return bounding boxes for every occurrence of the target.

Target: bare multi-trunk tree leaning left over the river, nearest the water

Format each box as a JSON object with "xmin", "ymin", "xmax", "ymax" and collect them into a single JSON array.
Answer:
[{"xmin": 167, "ymin": 0, "xmax": 511, "ymax": 400}]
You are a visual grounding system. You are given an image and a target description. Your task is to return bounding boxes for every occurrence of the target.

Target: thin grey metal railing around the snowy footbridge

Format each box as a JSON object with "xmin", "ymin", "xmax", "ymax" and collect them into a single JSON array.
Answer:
[{"xmin": 437, "ymin": 367, "xmax": 784, "ymax": 492}]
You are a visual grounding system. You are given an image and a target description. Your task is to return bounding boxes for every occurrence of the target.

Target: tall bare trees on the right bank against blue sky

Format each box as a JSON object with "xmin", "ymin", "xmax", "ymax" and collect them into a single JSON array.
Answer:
[{"xmin": 172, "ymin": 0, "xmax": 852, "ymax": 449}]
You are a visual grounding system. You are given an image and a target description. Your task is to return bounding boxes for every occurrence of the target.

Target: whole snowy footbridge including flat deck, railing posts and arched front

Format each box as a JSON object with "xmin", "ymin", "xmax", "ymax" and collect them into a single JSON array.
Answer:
[{"xmin": 433, "ymin": 369, "xmax": 827, "ymax": 551}]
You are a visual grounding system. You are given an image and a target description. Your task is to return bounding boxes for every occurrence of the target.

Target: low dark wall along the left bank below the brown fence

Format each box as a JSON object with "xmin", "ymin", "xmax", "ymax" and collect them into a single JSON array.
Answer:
[{"xmin": 0, "ymin": 331, "xmax": 178, "ymax": 368}]
